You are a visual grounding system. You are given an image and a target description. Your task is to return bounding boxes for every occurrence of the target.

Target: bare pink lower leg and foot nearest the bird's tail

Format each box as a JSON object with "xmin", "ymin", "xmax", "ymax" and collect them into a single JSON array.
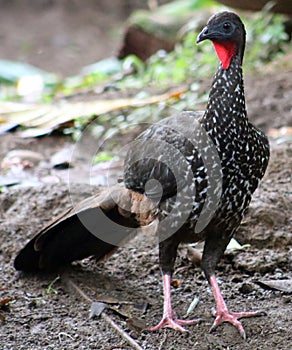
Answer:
[{"xmin": 149, "ymin": 274, "xmax": 196, "ymax": 332}]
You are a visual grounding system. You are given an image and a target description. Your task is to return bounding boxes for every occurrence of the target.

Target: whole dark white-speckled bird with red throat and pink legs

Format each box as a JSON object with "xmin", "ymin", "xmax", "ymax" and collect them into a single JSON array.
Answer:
[{"xmin": 14, "ymin": 11, "xmax": 270, "ymax": 339}]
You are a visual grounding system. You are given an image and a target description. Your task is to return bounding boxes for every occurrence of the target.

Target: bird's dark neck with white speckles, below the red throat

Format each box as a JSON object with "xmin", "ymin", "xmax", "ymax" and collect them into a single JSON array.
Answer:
[{"xmin": 203, "ymin": 55, "xmax": 248, "ymax": 129}]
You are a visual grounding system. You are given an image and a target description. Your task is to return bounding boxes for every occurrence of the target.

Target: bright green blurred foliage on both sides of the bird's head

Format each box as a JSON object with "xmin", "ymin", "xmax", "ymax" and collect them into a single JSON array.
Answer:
[{"xmin": 118, "ymin": 11, "xmax": 287, "ymax": 89}]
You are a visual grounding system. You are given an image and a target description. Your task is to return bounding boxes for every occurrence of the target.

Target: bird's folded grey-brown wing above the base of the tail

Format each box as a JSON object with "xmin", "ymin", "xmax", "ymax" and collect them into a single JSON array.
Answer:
[{"xmin": 124, "ymin": 111, "xmax": 204, "ymax": 201}]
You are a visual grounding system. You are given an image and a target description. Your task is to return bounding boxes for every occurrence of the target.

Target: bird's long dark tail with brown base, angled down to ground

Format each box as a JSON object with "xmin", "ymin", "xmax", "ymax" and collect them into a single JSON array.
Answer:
[{"xmin": 14, "ymin": 185, "xmax": 155, "ymax": 272}]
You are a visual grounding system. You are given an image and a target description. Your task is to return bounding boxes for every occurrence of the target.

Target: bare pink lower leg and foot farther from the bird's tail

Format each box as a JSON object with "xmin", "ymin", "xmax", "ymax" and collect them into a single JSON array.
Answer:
[{"xmin": 210, "ymin": 275, "xmax": 264, "ymax": 339}]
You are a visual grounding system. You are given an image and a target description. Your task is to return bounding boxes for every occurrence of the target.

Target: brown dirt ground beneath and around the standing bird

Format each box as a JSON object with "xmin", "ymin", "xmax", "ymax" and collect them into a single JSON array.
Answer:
[{"xmin": 0, "ymin": 2, "xmax": 292, "ymax": 350}]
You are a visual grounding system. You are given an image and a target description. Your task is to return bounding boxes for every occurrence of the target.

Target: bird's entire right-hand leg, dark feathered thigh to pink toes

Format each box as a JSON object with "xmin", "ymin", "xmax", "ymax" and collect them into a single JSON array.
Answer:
[{"xmin": 202, "ymin": 236, "xmax": 264, "ymax": 339}]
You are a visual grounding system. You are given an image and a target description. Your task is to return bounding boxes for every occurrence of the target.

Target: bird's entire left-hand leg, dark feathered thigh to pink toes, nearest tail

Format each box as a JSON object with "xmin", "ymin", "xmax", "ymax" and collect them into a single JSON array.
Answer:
[{"xmin": 149, "ymin": 239, "xmax": 196, "ymax": 332}]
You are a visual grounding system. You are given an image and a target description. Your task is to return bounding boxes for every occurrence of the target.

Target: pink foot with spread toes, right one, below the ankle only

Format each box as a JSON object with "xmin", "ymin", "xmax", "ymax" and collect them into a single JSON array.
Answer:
[{"xmin": 210, "ymin": 310, "xmax": 265, "ymax": 340}]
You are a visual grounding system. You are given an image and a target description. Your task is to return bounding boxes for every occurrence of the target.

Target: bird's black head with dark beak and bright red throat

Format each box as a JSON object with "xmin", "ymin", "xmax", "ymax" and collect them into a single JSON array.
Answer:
[{"xmin": 197, "ymin": 11, "xmax": 245, "ymax": 69}]
